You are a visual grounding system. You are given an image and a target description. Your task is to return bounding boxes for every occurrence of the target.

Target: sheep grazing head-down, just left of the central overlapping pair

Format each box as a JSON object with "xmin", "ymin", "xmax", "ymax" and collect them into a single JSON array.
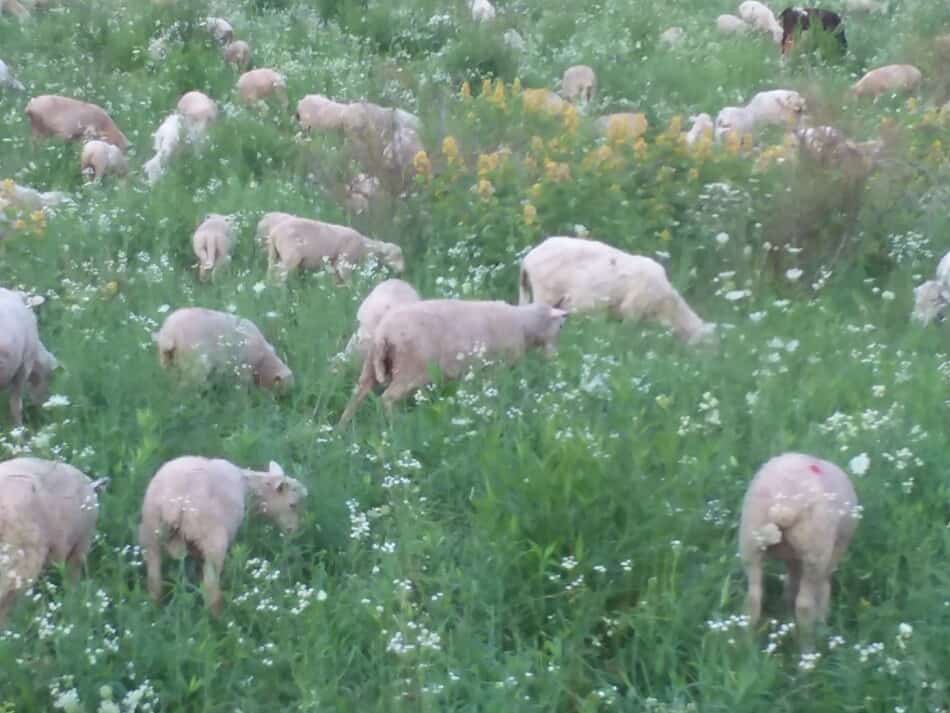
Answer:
[{"xmin": 152, "ymin": 307, "xmax": 294, "ymax": 391}]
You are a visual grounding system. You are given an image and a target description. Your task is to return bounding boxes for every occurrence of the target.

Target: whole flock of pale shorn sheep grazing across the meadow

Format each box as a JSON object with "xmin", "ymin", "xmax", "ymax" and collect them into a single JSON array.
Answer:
[{"xmin": 0, "ymin": 0, "xmax": 950, "ymax": 646}]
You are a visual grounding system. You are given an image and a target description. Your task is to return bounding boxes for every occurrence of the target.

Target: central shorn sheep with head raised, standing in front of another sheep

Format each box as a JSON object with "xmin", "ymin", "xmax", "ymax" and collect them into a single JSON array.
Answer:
[{"xmin": 338, "ymin": 300, "xmax": 567, "ymax": 428}]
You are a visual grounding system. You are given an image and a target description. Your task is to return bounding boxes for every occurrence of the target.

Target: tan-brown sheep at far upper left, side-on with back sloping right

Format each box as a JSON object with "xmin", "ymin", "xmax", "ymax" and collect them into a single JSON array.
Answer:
[{"xmin": 25, "ymin": 94, "xmax": 129, "ymax": 152}]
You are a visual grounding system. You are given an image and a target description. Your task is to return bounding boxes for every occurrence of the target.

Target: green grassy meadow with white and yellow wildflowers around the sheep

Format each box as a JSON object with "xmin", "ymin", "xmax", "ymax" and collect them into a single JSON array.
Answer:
[{"xmin": 0, "ymin": 0, "xmax": 950, "ymax": 713}]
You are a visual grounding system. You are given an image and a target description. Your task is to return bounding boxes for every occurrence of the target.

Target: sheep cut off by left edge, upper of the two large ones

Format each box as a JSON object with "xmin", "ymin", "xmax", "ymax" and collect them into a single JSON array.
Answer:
[{"xmin": 0, "ymin": 287, "xmax": 59, "ymax": 426}]
